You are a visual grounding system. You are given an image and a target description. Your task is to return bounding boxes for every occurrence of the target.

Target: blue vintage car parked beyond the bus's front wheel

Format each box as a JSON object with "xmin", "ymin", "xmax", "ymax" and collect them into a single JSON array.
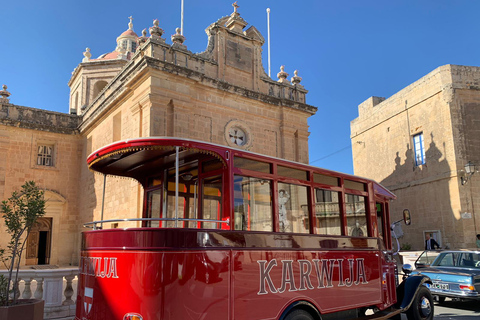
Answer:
[{"xmin": 412, "ymin": 249, "xmax": 480, "ymax": 302}]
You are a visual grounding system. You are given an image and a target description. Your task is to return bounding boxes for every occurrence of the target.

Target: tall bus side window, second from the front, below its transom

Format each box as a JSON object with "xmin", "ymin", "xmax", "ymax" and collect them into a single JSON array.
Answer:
[{"xmin": 315, "ymin": 189, "xmax": 342, "ymax": 235}]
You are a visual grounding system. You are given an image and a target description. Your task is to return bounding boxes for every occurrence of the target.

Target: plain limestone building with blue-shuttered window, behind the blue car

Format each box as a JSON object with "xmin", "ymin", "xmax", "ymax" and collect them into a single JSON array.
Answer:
[{"xmin": 351, "ymin": 65, "xmax": 480, "ymax": 250}]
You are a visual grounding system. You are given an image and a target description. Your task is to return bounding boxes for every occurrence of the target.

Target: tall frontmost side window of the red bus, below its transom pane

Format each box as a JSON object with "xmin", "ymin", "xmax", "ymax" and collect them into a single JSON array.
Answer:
[{"xmin": 345, "ymin": 194, "xmax": 368, "ymax": 237}]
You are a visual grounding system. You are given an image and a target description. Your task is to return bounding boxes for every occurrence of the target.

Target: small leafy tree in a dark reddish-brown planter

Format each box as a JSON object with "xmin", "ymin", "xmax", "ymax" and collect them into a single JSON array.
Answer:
[{"xmin": 0, "ymin": 181, "xmax": 45, "ymax": 320}]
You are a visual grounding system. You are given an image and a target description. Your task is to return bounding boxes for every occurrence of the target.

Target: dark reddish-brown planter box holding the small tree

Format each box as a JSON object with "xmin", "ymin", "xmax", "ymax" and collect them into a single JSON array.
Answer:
[{"xmin": 0, "ymin": 299, "xmax": 44, "ymax": 320}]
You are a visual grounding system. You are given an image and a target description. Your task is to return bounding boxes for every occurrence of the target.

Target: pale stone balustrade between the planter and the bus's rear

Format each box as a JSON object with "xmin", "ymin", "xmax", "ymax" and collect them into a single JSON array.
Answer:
[{"xmin": 0, "ymin": 267, "xmax": 78, "ymax": 320}]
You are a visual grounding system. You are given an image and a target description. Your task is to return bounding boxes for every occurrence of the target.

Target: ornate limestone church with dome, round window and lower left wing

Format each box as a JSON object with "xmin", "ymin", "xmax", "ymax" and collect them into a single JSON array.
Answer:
[{"xmin": 0, "ymin": 6, "xmax": 317, "ymax": 265}]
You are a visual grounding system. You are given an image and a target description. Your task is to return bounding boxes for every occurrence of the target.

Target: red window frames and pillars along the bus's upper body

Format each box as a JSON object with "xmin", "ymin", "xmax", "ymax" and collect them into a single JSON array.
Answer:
[{"xmin": 142, "ymin": 146, "xmax": 390, "ymax": 239}]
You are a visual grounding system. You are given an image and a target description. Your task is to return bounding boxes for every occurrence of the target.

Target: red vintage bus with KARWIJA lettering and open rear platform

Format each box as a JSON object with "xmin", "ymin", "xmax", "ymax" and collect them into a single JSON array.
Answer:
[{"xmin": 76, "ymin": 138, "xmax": 433, "ymax": 320}]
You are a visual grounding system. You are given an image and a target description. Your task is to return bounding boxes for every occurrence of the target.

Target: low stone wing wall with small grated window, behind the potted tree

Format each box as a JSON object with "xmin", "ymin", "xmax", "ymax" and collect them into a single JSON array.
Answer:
[{"xmin": 0, "ymin": 104, "xmax": 83, "ymax": 265}]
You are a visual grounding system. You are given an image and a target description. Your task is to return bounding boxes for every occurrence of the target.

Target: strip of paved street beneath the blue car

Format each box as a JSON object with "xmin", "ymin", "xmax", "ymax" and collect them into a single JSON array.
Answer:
[{"xmin": 434, "ymin": 299, "xmax": 480, "ymax": 320}]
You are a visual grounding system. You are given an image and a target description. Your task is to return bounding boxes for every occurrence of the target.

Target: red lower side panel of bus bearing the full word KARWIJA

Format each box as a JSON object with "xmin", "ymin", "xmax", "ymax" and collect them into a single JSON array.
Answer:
[{"xmin": 233, "ymin": 251, "xmax": 383, "ymax": 320}]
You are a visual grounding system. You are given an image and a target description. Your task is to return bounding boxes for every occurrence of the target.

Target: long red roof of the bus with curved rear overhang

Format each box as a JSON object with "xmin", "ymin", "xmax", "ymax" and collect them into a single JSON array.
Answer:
[{"xmin": 87, "ymin": 137, "xmax": 396, "ymax": 199}]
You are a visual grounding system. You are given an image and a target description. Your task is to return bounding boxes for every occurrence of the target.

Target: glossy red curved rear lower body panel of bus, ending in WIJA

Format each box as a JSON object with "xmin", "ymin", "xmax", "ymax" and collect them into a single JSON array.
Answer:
[{"xmin": 76, "ymin": 250, "xmax": 230, "ymax": 320}]
